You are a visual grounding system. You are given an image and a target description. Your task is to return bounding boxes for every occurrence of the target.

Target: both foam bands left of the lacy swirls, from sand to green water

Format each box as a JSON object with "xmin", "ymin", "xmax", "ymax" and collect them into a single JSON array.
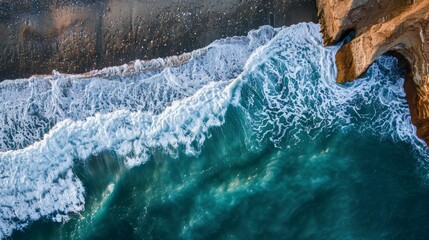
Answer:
[{"xmin": 0, "ymin": 26, "xmax": 278, "ymax": 238}]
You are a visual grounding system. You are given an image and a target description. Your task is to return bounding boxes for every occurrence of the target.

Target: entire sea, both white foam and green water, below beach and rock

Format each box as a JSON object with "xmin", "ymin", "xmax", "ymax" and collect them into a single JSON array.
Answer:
[{"xmin": 0, "ymin": 23, "xmax": 429, "ymax": 239}]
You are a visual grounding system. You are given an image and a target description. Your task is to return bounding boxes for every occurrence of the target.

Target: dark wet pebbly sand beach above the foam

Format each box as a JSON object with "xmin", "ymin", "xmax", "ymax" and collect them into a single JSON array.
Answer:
[{"xmin": 0, "ymin": 0, "xmax": 317, "ymax": 81}]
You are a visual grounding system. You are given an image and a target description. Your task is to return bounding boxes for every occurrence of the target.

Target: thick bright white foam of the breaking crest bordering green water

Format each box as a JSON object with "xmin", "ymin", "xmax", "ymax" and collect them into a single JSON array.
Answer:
[{"xmin": 0, "ymin": 79, "xmax": 232, "ymax": 236}]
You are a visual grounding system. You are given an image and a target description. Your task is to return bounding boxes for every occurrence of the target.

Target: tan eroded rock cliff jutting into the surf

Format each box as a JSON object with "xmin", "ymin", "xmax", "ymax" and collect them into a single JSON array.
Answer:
[{"xmin": 317, "ymin": 0, "xmax": 429, "ymax": 145}]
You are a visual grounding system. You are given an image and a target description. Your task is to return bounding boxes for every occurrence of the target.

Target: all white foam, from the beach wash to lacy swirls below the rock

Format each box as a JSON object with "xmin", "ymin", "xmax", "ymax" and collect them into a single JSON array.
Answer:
[{"xmin": 0, "ymin": 23, "xmax": 427, "ymax": 238}]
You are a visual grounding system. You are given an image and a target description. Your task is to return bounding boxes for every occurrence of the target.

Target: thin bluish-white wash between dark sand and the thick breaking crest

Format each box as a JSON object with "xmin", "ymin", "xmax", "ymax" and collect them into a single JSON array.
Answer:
[{"xmin": 0, "ymin": 26, "xmax": 278, "ymax": 151}]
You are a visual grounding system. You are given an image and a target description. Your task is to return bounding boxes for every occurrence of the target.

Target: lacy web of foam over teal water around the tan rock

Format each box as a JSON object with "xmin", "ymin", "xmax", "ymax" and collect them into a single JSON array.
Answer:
[{"xmin": 242, "ymin": 24, "xmax": 429, "ymax": 159}]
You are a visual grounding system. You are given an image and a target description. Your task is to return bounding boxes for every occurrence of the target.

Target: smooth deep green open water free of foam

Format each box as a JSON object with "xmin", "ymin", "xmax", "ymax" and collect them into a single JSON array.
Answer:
[{"xmin": 14, "ymin": 111, "xmax": 429, "ymax": 239}]
